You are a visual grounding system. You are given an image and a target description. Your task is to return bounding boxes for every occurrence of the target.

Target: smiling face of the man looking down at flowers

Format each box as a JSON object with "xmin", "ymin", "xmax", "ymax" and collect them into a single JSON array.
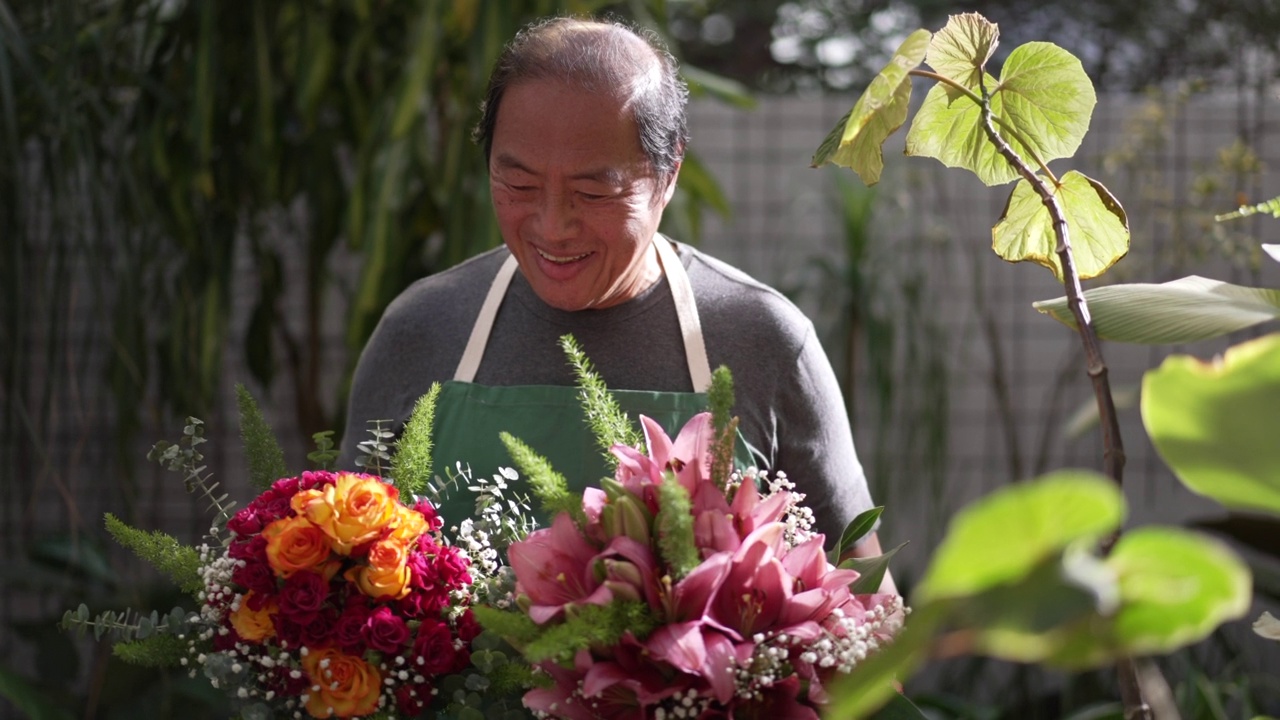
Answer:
[{"xmin": 489, "ymin": 81, "xmax": 676, "ymax": 310}]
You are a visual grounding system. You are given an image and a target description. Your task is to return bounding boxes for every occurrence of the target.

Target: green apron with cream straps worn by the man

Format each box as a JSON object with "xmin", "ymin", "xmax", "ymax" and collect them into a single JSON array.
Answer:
[{"xmin": 431, "ymin": 236, "xmax": 754, "ymax": 528}]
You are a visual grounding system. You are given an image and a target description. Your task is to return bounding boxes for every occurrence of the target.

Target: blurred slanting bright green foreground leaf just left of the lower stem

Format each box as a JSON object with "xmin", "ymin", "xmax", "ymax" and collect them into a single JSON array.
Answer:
[{"xmin": 914, "ymin": 470, "xmax": 1125, "ymax": 602}]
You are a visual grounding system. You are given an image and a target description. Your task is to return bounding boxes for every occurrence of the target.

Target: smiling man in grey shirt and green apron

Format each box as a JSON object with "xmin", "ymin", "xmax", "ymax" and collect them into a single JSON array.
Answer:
[{"xmin": 343, "ymin": 18, "xmax": 879, "ymax": 563}]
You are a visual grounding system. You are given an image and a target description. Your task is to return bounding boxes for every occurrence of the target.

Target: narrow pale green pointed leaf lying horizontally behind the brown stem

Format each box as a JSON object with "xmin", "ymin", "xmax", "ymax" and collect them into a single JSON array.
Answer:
[{"xmin": 1033, "ymin": 275, "xmax": 1280, "ymax": 345}]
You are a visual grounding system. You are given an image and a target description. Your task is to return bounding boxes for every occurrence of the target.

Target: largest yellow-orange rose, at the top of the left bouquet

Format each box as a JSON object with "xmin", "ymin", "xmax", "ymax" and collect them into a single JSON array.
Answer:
[{"xmin": 291, "ymin": 473, "xmax": 402, "ymax": 555}]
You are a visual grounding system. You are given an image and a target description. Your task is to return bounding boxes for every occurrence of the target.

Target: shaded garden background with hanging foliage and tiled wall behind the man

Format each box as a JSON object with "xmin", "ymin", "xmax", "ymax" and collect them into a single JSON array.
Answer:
[{"xmin": 0, "ymin": 0, "xmax": 1280, "ymax": 717}]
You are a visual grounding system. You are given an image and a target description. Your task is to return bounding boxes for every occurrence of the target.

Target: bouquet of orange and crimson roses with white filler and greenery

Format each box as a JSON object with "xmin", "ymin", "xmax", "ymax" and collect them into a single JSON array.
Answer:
[{"xmin": 63, "ymin": 389, "xmax": 532, "ymax": 720}]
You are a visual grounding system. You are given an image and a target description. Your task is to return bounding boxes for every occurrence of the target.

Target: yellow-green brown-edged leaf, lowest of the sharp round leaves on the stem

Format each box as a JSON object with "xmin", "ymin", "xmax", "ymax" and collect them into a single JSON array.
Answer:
[{"xmin": 991, "ymin": 170, "xmax": 1129, "ymax": 282}]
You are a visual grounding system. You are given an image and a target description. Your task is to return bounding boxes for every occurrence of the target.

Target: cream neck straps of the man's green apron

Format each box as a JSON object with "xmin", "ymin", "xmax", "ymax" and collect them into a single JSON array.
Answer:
[{"xmin": 453, "ymin": 234, "xmax": 712, "ymax": 392}]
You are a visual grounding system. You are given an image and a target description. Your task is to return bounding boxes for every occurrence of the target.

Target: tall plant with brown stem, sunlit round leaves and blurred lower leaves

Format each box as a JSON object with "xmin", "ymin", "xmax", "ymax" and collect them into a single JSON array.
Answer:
[{"xmin": 813, "ymin": 13, "xmax": 1259, "ymax": 719}]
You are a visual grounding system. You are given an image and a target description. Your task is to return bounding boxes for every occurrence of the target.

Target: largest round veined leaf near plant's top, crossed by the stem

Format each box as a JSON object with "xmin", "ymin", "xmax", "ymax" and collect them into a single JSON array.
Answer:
[{"xmin": 906, "ymin": 42, "xmax": 1097, "ymax": 186}]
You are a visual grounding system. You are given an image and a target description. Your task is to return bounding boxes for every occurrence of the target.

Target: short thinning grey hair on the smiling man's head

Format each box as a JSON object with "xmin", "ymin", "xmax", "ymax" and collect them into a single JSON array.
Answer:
[{"xmin": 474, "ymin": 17, "xmax": 689, "ymax": 181}]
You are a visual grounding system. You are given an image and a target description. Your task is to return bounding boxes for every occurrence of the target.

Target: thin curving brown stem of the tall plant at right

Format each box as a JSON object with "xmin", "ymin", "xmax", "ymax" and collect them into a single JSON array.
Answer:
[{"xmin": 982, "ymin": 92, "xmax": 1153, "ymax": 720}]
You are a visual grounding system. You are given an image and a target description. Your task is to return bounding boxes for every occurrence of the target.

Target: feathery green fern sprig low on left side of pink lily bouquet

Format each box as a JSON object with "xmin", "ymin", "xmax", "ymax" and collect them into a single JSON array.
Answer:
[{"xmin": 525, "ymin": 601, "xmax": 659, "ymax": 662}]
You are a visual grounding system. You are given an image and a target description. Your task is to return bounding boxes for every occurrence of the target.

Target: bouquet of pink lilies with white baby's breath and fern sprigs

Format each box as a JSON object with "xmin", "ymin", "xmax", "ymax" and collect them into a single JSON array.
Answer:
[{"xmin": 477, "ymin": 345, "xmax": 905, "ymax": 720}]
